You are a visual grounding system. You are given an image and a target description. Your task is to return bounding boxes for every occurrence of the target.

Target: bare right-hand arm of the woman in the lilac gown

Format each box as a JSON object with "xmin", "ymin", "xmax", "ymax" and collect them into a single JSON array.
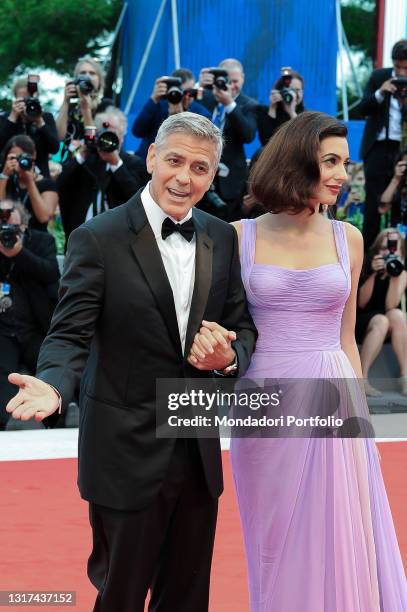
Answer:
[{"xmin": 341, "ymin": 223, "xmax": 363, "ymax": 378}]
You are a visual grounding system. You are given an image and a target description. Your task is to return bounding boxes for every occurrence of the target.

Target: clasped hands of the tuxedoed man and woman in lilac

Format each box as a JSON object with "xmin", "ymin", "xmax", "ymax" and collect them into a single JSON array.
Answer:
[{"xmin": 188, "ymin": 321, "xmax": 236, "ymax": 370}]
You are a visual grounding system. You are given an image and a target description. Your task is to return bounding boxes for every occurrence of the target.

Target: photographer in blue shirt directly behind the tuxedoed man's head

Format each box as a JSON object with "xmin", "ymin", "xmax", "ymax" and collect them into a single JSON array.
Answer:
[{"xmin": 132, "ymin": 68, "xmax": 210, "ymax": 159}]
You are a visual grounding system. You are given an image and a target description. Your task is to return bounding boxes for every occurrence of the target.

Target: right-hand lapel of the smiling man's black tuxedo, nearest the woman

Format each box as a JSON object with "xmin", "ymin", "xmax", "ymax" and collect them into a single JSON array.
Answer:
[{"xmin": 184, "ymin": 211, "xmax": 213, "ymax": 357}]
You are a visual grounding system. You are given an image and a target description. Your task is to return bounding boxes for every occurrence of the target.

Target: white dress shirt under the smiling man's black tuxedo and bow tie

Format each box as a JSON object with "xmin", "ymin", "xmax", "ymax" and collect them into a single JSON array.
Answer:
[{"xmin": 141, "ymin": 183, "xmax": 196, "ymax": 351}]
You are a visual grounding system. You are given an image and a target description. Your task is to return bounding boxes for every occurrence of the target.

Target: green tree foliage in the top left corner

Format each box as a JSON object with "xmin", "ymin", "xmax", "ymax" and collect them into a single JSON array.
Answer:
[{"xmin": 0, "ymin": 0, "xmax": 122, "ymax": 83}]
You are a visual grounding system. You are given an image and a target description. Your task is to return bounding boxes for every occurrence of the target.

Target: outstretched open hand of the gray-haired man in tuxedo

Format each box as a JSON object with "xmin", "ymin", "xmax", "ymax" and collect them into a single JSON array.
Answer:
[{"xmin": 6, "ymin": 372, "xmax": 59, "ymax": 421}]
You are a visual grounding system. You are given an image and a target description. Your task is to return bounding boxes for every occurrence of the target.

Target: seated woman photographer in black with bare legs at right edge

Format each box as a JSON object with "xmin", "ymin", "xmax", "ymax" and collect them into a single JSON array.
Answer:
[{"xmin": 356, "ymin": 228, "xmax": 407, "ymax": 397}]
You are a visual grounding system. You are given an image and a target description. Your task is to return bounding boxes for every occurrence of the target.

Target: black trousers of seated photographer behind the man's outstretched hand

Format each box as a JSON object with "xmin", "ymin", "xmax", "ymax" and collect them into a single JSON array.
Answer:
[{"xmin": 0, "ymin": 333, "xmax": 44, "ymax": 430}]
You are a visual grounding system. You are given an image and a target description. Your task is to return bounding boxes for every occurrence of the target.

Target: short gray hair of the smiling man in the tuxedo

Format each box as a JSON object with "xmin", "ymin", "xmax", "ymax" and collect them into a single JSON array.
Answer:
[{"xmin": 155, "ymin": 112, "xmax": 223, "ymax": 166}]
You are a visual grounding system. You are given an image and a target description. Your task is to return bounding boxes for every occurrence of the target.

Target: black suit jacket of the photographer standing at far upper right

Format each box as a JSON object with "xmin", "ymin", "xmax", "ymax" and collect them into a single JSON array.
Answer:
[{"xmin": 359, "ymin": 68, "xmax": 393, "ymax": 160}]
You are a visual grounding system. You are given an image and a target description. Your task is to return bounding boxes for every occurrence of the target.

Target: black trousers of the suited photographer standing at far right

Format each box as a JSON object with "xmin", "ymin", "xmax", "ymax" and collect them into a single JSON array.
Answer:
[{"xmin": 363, "ymin": 140, "xmax": 400, "ymax": 250}]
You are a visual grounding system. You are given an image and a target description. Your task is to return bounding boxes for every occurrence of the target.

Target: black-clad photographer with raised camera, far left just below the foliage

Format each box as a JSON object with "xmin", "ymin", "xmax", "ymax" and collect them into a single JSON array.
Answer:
[{"xmin": 0, "ymin": 75, "xmax": 59, "ymax": 177}]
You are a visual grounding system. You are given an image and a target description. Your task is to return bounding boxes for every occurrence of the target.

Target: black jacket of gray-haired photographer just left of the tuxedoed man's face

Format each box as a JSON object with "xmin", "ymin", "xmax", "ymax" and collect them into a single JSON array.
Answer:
[{"xmin": 57, "ymin": 151, "xmax": 148, "ymax": 243}]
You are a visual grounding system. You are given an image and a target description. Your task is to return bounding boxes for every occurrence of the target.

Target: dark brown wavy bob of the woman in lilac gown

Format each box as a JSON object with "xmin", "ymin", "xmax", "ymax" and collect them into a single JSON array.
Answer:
[{"xmin": 249, "ymin": 111, "xmax": 348, "ymax": 215}]
